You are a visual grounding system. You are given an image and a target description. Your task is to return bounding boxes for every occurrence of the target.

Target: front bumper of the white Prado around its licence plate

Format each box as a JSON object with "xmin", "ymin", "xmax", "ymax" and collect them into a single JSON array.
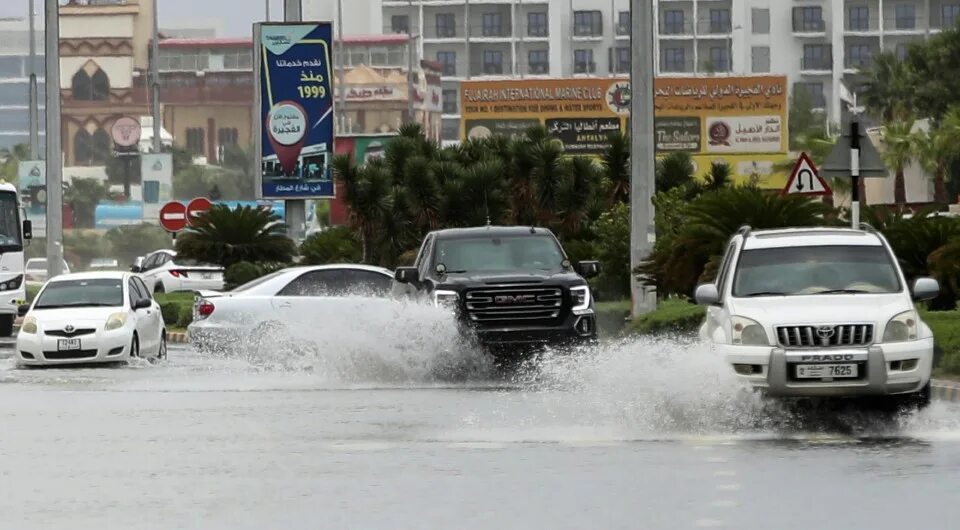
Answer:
[{"xmin": 716, "ymin": 338, "xmax": 933, "ymax": 397}]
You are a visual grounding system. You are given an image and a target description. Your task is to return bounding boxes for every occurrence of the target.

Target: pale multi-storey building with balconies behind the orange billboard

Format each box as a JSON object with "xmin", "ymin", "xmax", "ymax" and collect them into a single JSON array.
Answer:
[{"xmin": 304, "ymin": 0, "xmax": 960, "ymax": 139}]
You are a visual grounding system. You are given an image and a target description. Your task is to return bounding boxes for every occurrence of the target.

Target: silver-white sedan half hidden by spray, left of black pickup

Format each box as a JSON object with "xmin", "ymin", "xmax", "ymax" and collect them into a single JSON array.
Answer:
[{"xmin": 188, "ymin": 265, "xmax": 393, "ymax": 351}]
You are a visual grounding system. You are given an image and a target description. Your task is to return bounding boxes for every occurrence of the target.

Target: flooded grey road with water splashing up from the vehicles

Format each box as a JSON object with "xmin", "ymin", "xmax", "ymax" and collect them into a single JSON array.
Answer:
[{"xmin": 0, "ymin": 342, "xmax": 960, "ymax": 530}]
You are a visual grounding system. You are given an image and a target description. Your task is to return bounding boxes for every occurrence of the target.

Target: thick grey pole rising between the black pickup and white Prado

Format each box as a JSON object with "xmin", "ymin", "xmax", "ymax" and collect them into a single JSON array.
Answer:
[{"xmin": 630, "ymin": 0, "xmax": 657, "ymax": 316}]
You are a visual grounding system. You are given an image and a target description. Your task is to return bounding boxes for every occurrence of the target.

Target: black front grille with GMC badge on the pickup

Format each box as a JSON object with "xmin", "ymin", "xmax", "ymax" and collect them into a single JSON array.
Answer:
[{"xmin": 466, "ymin": 287, "xmax": 563, "ymax": 323}]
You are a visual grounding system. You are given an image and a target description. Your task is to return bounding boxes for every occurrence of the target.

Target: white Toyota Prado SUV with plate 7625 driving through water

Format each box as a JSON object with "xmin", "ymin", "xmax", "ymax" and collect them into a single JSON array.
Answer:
[{"xmin": 696, "ymin": 225, "xmax": 940, "ymax": 406}]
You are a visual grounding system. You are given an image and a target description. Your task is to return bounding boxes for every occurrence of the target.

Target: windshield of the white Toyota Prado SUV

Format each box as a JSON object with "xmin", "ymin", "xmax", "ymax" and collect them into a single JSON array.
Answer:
[{"xmin": 733, "ymin": 246, "xmax": 900, "ymax": 297}]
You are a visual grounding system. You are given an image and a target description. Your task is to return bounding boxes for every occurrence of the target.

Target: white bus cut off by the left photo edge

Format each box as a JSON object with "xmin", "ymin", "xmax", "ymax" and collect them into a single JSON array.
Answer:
[{"xmin": 0, "ymin": 182, "xmax": 33, "ymax": 337}]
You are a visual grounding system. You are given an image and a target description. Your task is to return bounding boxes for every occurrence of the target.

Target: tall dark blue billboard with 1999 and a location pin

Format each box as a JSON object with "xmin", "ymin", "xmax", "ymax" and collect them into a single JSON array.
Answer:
[{"xmin": 254, "ymin": 22, "xmax": 334, "ymax": 199}]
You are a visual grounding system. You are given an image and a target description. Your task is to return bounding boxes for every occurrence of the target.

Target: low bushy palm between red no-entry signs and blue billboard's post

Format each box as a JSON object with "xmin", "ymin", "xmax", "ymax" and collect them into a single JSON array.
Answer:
[{"xmin": 177, "ymin": 204, "xmax": 296, "ymax": 267}]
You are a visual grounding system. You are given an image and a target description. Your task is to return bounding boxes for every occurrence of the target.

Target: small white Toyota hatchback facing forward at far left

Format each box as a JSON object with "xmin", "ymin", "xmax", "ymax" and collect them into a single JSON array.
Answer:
[{"xmin": 16, "ymin": 272, "xmax": 167, "ymax": 366}]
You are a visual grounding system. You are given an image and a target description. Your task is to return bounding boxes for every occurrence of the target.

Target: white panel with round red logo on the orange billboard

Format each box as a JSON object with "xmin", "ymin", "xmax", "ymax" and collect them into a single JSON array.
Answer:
[{"xmin": 706, "ymin": 116, "xmax": 784, "ymax": 153}]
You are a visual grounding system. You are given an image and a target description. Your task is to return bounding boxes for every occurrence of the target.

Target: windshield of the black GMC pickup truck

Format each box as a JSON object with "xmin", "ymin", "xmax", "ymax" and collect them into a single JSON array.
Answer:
[{"xmin": 433, "ymin": 235, "xmax": 564, "ymax": 273}]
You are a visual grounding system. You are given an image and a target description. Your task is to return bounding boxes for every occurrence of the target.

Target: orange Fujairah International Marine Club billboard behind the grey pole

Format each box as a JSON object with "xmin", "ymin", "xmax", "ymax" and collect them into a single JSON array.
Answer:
[{"xmin": 460, "ymin": 76, "xmax": 787, "ymax": 155}]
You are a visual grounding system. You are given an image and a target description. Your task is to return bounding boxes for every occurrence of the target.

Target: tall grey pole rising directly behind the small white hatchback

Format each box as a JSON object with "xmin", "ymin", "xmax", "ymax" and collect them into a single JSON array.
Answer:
[{"xmin": 44, "ymin": 0, "xmax": 63, "ymax": 278}]
